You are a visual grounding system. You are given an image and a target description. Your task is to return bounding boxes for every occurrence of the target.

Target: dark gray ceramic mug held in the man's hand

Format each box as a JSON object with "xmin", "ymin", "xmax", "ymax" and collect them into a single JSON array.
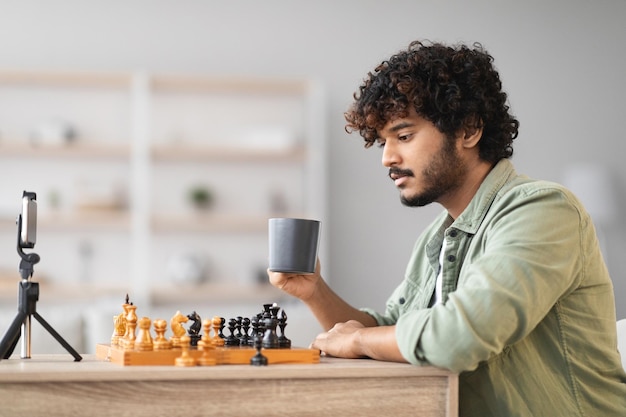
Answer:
[{"xmin": 268, "ymin": 218, "xmax": 320, "ymax": 274}]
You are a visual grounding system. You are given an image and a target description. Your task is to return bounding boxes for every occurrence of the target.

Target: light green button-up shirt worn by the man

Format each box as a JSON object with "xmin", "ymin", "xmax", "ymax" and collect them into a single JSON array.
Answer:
[{"xmin": 365, "ymin": 160, "xmax": 626, "ymax": 417}]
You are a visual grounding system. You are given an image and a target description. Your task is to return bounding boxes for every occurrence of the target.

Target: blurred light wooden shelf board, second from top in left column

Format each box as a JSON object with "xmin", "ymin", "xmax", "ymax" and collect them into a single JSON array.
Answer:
[{"xmin": 0, "ymin": 141, "xmax": 130, "ymax": 159}]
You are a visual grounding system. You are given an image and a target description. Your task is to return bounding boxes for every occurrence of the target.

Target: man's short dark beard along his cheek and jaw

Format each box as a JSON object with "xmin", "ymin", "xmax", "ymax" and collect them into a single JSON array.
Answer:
[{"xmin": 400, "ymin": 138, "xmax": 466, "ymax": 207}]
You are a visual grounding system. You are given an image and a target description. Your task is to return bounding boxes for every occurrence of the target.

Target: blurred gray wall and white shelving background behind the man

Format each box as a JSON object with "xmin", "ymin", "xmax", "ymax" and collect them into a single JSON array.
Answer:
[{"xmin": 0, "ymin": 0, "xmax": 626, "ymax": 353}]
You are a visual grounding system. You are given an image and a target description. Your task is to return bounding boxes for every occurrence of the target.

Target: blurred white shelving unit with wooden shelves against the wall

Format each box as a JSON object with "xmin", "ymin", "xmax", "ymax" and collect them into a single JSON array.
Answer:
[{"xmin": 0, "ymin": 70, "xmax": 326, "ymax": 307}]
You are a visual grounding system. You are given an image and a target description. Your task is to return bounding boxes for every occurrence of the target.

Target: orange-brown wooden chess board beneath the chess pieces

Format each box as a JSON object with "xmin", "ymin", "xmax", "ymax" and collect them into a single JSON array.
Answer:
[{"xmin": 96, "ymin": 344, "xmax": 320, "ymax": 366}]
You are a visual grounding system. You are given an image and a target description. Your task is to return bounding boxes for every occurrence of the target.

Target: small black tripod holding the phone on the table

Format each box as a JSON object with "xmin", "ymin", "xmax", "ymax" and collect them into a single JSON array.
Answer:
[{"xmin": 0, "ymin": 215, "xmax": 83, "ymax": 362}]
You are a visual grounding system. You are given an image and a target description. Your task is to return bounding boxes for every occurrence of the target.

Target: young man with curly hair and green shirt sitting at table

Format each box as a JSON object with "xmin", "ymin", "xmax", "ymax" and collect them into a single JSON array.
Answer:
[{"xmin": 269, "ymin": 42, "xmax": 626, "ymax": 417}]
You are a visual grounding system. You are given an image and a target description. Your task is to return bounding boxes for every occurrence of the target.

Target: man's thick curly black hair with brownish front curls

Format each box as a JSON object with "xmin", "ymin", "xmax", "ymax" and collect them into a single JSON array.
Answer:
[{"xmin": 345, "ymin": 41, "xmax": 519, "ymax": 163}]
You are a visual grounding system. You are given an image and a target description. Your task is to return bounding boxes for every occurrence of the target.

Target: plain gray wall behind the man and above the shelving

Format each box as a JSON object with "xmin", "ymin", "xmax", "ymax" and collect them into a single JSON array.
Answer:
[{"xmin": 0, "ymin": 0, "xmax": 626, "ymax": 317}]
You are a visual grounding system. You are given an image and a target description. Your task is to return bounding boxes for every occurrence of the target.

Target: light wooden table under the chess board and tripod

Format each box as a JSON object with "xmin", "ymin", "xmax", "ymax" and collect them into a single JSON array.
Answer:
[{"xmin": 0, "ymin": 355, "xmax": 458, "ymax": 417}]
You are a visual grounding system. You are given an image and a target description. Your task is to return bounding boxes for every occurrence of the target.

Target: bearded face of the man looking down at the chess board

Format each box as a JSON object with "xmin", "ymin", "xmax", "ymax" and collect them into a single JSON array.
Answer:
[{"xmin": 378, "ymin": 111, "xmax": 466, "ymax": 207}]
